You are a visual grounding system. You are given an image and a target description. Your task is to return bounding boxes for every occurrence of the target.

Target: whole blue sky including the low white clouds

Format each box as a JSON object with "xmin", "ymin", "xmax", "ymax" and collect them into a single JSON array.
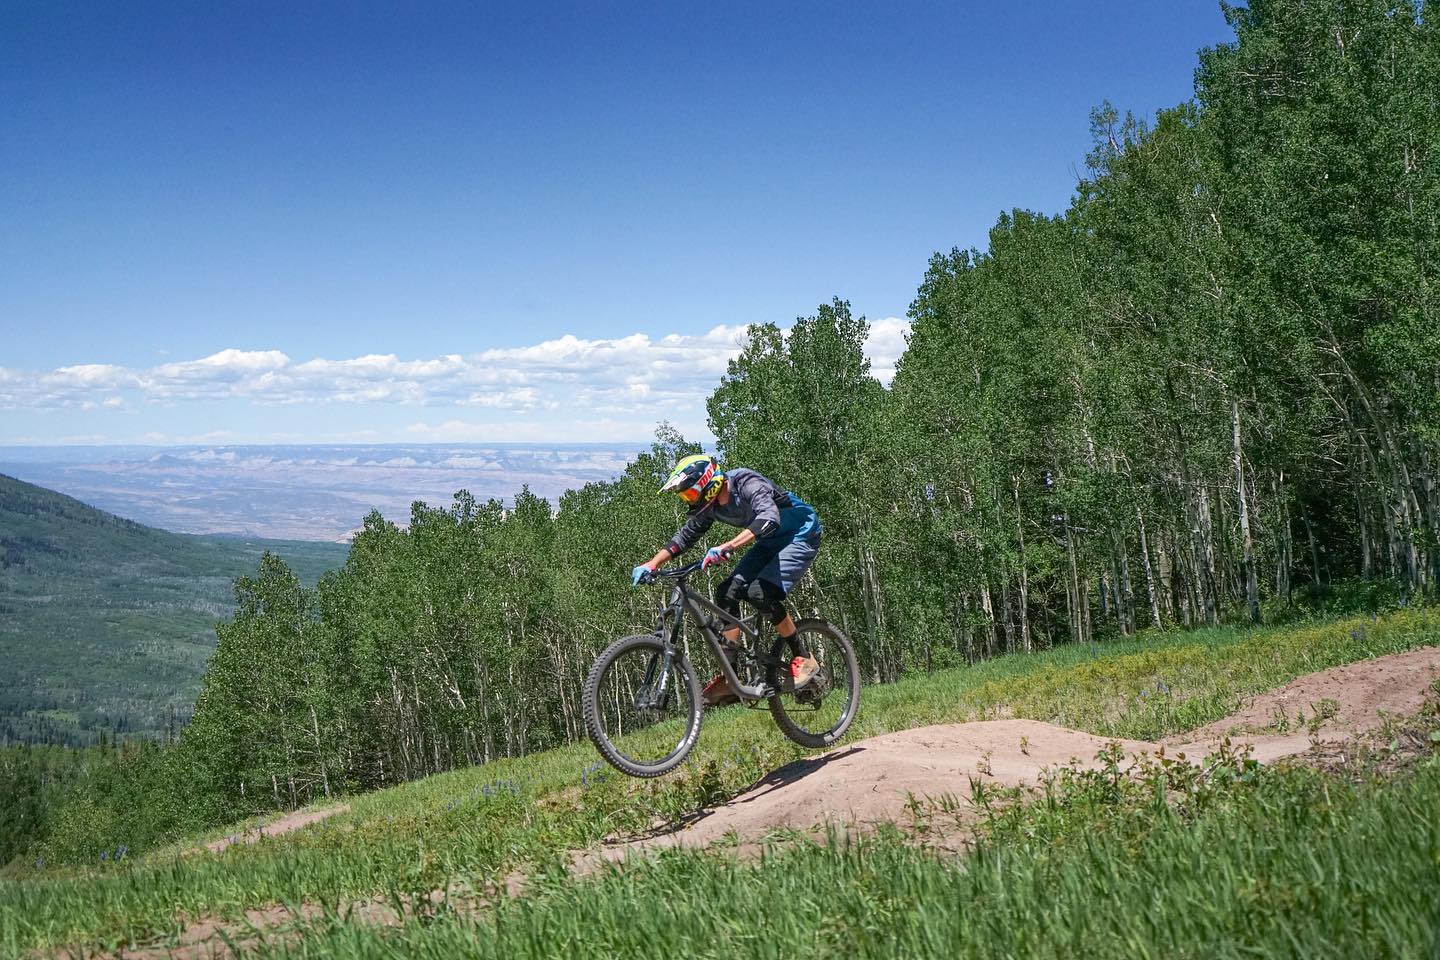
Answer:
[{"xmin": 0, "ymin": 0, "xmax": 1228, "ymax": 443}]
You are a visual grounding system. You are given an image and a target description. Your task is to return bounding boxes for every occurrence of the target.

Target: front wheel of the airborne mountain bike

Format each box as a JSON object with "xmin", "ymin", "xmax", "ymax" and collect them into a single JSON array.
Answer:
[{"xmin": 580, "ymin": 633, "xmax": 701, "ymax": 777}]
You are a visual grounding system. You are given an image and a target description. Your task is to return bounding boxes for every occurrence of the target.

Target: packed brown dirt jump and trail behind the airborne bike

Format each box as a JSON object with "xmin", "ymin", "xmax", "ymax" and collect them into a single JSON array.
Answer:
[{"xmin": 596, "ymin": 648, "xmax": 1440, "ymax": 869}]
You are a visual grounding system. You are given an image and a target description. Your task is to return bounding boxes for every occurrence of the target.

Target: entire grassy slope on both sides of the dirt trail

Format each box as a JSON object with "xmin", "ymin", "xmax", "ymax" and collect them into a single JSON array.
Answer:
[{"xmin": 0, "ymin": 609, "xmax": 1440, "ymax": 957}]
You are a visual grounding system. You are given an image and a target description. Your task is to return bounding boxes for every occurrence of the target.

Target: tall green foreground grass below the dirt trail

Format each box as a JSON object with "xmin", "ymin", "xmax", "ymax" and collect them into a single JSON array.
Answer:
[{"xmin": 258, "ymin": 761, "xmax": 1440, "ymax": 960}]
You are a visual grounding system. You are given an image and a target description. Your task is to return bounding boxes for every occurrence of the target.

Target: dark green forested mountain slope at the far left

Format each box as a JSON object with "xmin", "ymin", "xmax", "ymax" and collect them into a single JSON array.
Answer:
[{"xmin": 0, "ymin": 475, "xmax": 346, "ymax": 744}]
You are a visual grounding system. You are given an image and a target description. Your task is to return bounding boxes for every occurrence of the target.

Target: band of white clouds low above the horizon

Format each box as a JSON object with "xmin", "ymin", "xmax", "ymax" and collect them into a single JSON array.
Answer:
[{"xmin": 0, "ymin": 317, "xmax": 909, "ymax": 428}]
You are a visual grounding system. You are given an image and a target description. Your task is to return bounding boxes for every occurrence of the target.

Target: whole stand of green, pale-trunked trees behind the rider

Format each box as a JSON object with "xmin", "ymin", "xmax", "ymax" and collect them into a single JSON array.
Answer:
[{"xmin": 14, "ymin": 0, "xmax": 1440, "ymax": 857}]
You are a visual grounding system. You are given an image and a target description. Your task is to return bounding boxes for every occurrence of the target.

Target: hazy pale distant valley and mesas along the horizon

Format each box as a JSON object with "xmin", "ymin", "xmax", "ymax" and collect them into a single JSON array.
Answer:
[{"xmin": 0, "ymin": 443, "xmax": 642, "ymax": 541}]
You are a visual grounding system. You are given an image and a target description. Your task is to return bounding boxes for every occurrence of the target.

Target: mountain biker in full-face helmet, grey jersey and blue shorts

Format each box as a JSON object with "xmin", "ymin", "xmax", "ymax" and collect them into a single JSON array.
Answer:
[{"xmin": 631, "ymin": 455, "xmax": 822, "ymax": 707}]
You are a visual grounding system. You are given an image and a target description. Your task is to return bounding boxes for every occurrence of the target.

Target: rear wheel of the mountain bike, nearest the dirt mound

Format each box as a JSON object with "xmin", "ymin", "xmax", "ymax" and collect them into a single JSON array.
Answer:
[{"xmin": 765, "ymin": 620, "xmax": 860, "ymax": 747}]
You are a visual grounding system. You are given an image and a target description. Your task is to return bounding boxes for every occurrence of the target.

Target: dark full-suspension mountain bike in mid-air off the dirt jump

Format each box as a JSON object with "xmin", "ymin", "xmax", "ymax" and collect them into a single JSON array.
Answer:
[{"xmin": 580, "ymin": 563, "xmax": 860, "ymax": 777}]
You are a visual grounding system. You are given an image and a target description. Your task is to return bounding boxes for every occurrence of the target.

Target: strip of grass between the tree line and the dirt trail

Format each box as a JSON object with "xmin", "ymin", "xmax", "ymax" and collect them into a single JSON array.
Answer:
[{"xmin": 0, "ymin": 609, "xmax": 1440, "ymax": 953}]
